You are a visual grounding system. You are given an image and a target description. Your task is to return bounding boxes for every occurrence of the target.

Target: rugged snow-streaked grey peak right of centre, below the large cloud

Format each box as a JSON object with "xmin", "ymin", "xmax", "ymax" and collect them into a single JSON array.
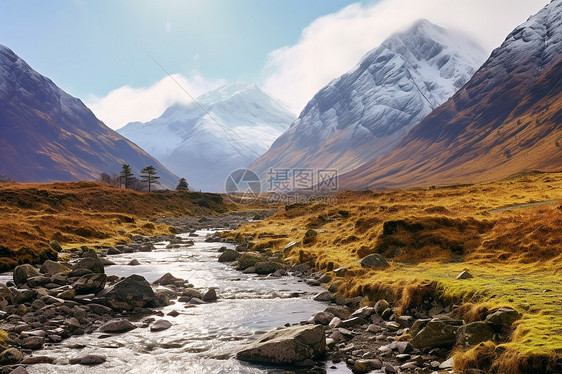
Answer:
[{"xmin": 250, "ymin": 20, "xmax": 486, "ymax": 181}]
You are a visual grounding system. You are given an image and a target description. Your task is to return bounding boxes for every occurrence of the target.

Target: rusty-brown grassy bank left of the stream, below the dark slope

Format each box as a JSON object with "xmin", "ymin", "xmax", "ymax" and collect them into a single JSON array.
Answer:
[{"xmin": 0, "ymin": 182, "xmax": 227, "ymax": 270}]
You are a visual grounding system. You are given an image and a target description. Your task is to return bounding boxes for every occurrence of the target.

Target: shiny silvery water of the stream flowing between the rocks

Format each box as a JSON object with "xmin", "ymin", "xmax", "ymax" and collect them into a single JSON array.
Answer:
[{"xmin": 18, "ymin": 231, "xmax": 350, "ymax": 374}]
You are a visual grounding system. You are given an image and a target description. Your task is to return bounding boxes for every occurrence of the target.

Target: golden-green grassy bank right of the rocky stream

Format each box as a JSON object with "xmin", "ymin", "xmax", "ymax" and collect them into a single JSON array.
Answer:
[{"xmin": 229, "ymin": 173, "xmax": 562, "ymax": 373}]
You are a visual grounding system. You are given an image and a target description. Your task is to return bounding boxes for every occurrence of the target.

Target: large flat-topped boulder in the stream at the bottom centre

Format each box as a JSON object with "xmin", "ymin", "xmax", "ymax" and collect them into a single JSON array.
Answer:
[{"xmin": 236, "ymin": 325, "xmax": 326, "ymax": 364}]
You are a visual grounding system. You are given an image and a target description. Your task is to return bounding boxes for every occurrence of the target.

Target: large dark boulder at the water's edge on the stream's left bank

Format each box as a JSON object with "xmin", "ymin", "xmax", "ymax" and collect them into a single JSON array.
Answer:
[{"xmin": 98, "ymin": 274, "xmax": 154, "ymax": 310}]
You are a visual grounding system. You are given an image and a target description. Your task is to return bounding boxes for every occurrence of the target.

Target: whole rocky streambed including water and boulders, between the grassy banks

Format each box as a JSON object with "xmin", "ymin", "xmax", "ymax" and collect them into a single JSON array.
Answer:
[{"xmin": 0, "ymin": 211, "xmax": 519, "ymax": 374}]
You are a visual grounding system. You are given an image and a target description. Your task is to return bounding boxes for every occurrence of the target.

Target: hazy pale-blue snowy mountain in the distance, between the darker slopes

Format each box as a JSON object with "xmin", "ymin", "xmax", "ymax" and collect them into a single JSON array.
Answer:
[{"xmin": 117, "ymin": 84, "xmax": 295, "ymax": 192}]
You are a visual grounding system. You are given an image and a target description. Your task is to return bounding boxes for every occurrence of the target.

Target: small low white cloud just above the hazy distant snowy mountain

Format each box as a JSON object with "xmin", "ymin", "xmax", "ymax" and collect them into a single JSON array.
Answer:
[{"xmin": 86, "ymin": 74, "xmax": 226, "ymax": 129}]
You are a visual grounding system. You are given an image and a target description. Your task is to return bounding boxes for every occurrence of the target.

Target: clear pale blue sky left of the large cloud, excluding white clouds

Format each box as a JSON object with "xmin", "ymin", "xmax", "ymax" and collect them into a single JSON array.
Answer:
[{"xmin": 0, "ymin": 0, "xmax": 354, "ymax": 98}]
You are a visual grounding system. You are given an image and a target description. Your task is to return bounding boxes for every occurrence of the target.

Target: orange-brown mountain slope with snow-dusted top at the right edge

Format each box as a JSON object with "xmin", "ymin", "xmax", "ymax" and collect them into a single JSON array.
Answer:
[{"xmin": 340, "ymin": 0, "xmax": 562, "ymax": 189}]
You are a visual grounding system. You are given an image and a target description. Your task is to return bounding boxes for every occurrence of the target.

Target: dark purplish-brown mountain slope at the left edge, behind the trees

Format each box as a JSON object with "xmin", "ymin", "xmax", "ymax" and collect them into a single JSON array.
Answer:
[{"xmin": 0, "ymin": 45, "xmax": 178, "ymax": 187}]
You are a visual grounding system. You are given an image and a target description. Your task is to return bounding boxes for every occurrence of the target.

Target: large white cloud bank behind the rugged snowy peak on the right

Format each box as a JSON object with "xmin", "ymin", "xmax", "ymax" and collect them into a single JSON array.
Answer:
[{"xmin": 263, "ymin": 0, "xmax": 549, "ymax": 113}]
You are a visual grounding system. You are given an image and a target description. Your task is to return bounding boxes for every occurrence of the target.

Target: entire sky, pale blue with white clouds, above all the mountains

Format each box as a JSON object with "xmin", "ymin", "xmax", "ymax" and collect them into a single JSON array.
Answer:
[{"xmin": 0, "ymin": 0, "xmax": 549, "ymax": 129}]
